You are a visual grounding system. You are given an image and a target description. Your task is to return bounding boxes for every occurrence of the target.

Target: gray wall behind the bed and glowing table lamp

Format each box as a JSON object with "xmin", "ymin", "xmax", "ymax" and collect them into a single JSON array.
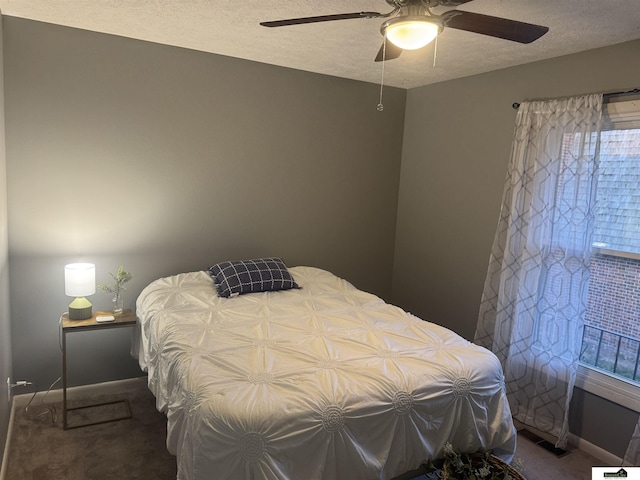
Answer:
[{"xmin": 4, "ymin": 17, "xmax": 406, "ymax": 389}]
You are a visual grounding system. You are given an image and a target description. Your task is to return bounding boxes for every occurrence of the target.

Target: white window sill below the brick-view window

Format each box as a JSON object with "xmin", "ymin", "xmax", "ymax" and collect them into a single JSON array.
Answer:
[{"xmin": 576, "ymin": 365, "xmax": 640, "ymax": 412}]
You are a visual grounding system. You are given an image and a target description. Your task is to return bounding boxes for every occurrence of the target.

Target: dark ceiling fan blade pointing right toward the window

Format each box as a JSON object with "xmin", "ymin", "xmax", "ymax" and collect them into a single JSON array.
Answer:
[{"xmin": 441, "ymin": 10, "xmax": 549, "ymax": 43}]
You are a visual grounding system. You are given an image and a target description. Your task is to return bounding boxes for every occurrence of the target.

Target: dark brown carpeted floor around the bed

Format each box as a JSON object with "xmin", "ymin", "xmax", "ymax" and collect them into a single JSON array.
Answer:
[{"xmin": 3, "ymin": 378, "xmax": 602, "ymax": 480}]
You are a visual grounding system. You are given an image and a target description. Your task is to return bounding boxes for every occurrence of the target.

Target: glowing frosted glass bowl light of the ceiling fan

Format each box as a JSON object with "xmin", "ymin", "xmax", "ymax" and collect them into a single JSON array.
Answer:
[{"xmin": 382, "ymin": 15, "xmax": 442, "ymax": 50}]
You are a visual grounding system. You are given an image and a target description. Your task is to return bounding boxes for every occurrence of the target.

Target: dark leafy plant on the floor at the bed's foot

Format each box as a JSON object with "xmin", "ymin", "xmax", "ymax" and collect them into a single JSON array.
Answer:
[{"xmin": 425, "ymin": 443, "xmax": 526, "ymax": 480}]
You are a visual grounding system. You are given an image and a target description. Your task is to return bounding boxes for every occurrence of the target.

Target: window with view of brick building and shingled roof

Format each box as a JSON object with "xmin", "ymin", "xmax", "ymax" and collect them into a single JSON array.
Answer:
[{"xmin": 580, "ymin": 97, "xmax": 640, "ymax": 402}]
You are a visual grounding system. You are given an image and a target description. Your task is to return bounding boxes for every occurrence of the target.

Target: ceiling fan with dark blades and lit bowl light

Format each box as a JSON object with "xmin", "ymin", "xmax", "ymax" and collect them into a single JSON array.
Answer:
[{"xmin": 260, "ymin": 0, "xmax": 549, "ymax": 62}]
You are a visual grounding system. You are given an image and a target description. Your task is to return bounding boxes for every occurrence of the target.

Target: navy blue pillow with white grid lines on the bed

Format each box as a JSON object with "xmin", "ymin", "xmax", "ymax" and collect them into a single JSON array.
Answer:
[{"xmin": 209, "ymin": 257, "xmax": 299, "ymax": 297}]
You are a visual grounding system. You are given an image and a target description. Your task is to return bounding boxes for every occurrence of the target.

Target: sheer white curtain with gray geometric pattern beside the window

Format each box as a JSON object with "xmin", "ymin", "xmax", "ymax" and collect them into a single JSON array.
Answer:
[{"xmin": 475, "ymin": 95, "xmax": 602, "ymax": 447}]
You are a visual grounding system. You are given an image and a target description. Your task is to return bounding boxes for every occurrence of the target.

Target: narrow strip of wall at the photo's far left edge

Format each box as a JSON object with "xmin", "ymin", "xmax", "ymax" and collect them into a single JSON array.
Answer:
[{"xmin": 0, "ymin": 10, "xmax": 11, "ymax": 458}]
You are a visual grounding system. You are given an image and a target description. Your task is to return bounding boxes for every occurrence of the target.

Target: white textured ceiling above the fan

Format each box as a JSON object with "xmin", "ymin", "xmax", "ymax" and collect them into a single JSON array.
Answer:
[{"xmin": 0, "ymin": 0, "xmax": 640, "ymax": 88}]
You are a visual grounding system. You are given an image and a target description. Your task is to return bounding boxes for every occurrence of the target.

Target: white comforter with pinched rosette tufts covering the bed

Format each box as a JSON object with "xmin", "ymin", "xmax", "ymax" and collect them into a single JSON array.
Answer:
[{"xmin": 137, "ymin": 267, "xmax": 516, "ymax": 480}]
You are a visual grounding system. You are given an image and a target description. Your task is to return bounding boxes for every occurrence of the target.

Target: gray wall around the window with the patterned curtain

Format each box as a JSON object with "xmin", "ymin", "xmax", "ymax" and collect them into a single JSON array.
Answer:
[{"xmin": 392, "ymin": 37, "xmax": 640, "ymax": 456}]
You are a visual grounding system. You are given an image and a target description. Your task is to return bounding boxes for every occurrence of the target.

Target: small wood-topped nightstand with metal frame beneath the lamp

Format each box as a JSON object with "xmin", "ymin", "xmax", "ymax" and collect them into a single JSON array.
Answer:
[{"xmin": 60, "ymin": 310, "xmax": 136, "ymax": 430}]
